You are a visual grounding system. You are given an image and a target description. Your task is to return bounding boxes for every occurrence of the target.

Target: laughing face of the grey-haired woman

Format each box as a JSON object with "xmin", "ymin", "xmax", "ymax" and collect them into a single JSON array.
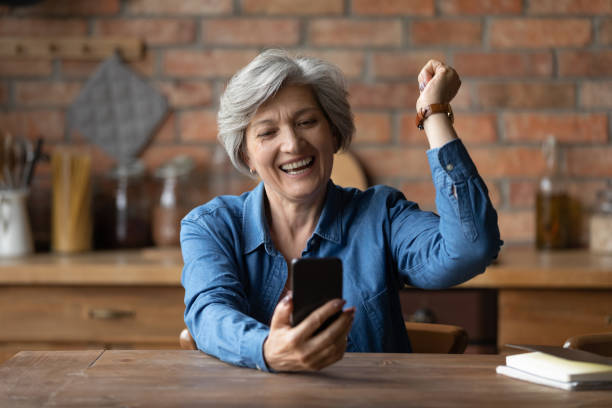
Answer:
[{"xmin": 245, "ymin": 85, "xmax": 337, "ymax": 207}]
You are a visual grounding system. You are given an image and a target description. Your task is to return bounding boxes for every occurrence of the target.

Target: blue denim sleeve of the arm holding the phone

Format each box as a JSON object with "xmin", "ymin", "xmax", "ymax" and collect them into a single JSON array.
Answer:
[{"xmin": 181, "ymin": 213, "xmax": 269, "ymax": 371}]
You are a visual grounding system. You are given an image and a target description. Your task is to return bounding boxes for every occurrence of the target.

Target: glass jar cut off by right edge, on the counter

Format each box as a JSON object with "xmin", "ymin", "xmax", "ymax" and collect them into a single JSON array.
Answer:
[{"xmin": 589, "ymin": 180, "xmax": 612, "ymax": 253}]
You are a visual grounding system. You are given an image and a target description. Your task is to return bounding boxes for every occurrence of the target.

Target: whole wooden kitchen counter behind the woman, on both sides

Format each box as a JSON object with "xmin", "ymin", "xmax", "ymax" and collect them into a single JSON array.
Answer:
[{"xmin": 0, "ymin": 247, "xmax": 612, "ymax": 362}]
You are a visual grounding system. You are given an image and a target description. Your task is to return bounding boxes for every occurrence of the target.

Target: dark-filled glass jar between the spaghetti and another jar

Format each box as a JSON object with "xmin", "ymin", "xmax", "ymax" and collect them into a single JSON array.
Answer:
[{"xmin": 95, "ymin": 160, "xmax": 151, "ymax": 249}]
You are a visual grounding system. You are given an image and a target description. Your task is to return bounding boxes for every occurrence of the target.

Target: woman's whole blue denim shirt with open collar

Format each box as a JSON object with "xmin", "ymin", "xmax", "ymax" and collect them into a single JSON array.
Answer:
[{"xmin": 181, "ymin": 140, "xmax": 502, "ymax": 370}]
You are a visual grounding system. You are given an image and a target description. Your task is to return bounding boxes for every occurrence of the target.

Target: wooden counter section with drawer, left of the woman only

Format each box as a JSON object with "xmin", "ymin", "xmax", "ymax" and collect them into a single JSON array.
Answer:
[{"xmin": 0, "ymin": 251, "xmax": 185, "ymax": 363}]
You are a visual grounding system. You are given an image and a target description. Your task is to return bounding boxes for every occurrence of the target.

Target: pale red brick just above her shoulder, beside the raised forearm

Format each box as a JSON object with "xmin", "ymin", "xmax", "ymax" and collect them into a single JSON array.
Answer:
[{"xmin": 353, "ymin": 147, "xmax": 431, "ymax": 179}]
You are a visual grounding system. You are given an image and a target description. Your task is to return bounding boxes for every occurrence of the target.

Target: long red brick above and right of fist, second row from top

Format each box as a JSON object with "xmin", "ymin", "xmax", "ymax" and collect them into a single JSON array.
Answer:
[{"xmin": 490, "ymin": 18, "xmax": 591, "ymax": 48}]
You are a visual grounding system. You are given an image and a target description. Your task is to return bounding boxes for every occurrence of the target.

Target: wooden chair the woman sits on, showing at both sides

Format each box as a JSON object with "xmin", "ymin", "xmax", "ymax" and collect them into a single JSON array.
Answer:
[{"xmin": 179, "ymin": 322, "xmax": 468, "ymax": 354}]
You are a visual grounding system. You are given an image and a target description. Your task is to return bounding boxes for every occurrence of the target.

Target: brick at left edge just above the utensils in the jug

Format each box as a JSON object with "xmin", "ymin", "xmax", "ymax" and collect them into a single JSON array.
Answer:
[{"xmin": 0, "ymin": 110, "xmax": 65, "ymax": 141}]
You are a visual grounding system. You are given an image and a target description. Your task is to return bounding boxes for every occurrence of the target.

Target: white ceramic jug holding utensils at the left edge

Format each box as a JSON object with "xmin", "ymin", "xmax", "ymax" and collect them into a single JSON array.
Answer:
[{"xmin": 0, "ymin": 189, "xmax": 34, "ymax": 257}]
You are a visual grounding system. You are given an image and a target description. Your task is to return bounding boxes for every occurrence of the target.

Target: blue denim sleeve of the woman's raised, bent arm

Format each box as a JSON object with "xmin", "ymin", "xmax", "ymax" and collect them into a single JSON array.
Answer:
[{"xmin": 390, "ymin": 139, "xmax": 503, "ymax": 289}]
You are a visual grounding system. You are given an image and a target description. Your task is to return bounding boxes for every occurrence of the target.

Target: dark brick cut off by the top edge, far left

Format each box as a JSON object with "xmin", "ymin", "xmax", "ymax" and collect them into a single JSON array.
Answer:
[{"xmin": 17, "ymin": 0, "xmax": 119, "ymax": 16}]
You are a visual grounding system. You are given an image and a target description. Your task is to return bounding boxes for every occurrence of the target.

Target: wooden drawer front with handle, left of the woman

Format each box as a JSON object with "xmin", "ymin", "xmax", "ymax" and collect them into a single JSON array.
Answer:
[{"xmin": 0, "ymin": 286, "xmax": 185, "ymax": 344}]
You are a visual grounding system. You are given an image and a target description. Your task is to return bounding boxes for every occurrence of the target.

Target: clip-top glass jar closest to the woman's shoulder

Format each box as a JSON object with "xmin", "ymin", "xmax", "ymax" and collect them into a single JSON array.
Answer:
[{"xmin": 152, "ymin": 156, "xmax": 194, "ymax": 246}]
